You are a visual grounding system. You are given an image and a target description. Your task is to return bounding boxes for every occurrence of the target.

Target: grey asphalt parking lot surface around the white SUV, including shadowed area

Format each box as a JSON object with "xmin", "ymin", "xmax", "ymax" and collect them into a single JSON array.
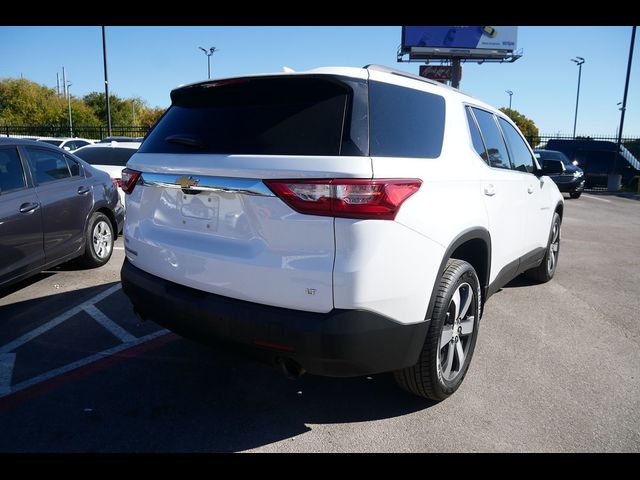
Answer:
[{"xmin": 0, "ymin": 194, "xmax": 640, "ymax": 452}]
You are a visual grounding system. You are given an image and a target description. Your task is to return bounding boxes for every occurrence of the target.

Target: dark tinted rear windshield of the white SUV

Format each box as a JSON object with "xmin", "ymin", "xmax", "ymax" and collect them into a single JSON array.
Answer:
[{"xmin": 140, "ymin": 75, "xmax": 368, "ymax": 155}]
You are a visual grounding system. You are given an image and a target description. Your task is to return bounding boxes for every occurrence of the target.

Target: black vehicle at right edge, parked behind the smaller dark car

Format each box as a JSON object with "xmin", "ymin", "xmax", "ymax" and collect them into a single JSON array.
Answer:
[{"xmin": 546, "ymin": 138, "xmax": 640, "ymax": 188}]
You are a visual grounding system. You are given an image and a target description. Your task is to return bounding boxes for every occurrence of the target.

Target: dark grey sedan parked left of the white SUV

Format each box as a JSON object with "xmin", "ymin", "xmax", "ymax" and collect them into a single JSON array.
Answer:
[{"xmin": 0, "ymin": 138, "xmax": 124, "ymax": 287}]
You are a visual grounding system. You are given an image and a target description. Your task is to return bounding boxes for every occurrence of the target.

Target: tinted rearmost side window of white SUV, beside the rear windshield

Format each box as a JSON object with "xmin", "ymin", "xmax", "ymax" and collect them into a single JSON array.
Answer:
[{"xmin": 369, "ymin": 81, "xmax": 445, "ymax": 158}]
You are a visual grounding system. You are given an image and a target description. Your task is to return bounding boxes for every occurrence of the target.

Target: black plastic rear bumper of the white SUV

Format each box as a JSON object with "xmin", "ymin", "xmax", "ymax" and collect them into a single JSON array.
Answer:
[{"xmin": 121, "ymin": 259, "xmax": 429, "ymax": 377}]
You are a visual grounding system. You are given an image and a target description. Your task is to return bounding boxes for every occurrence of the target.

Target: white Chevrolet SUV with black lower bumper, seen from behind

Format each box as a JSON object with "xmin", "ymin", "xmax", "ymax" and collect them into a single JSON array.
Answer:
[{"xmin": 121, "ymin": 66, "xmax": 563, "ymax": 400}]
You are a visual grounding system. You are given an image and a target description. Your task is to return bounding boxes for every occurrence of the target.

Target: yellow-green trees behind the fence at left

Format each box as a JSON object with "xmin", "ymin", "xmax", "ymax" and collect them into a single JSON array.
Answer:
[{"xmin": 0, "ymin": 78, "xmax": 164, "ymax": 126}]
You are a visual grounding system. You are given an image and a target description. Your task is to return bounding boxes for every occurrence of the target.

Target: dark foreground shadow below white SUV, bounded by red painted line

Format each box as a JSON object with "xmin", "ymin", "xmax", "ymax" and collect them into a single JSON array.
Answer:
[{"xmin": 0, "ymin": 294, "xmax": 433, "ymax": 452}]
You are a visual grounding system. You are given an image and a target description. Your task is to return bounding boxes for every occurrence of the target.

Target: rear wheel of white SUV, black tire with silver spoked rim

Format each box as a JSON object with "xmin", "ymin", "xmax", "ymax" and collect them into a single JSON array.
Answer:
[{"xmin": 394, "ymin": 259, "xmax": 481, "ymax": 401}]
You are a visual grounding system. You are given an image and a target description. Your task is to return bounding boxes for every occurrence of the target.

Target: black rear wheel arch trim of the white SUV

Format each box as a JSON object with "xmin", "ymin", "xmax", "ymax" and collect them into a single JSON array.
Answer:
[{"xmin": 426, "ymin": 227, "xmax": 491, "ymax": 319}]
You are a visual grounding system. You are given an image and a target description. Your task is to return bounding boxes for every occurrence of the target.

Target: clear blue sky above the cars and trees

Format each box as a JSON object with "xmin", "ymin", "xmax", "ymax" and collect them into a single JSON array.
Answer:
[{"xmin": 0, "ymin": 26, "xmax": 640, "ymax": 136}]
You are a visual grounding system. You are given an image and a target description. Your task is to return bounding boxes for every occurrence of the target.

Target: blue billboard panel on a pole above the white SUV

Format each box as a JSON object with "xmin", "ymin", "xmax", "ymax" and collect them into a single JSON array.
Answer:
[{"xmin": 402, "ymin": 26, "xmax": 518, "ymax": 52}]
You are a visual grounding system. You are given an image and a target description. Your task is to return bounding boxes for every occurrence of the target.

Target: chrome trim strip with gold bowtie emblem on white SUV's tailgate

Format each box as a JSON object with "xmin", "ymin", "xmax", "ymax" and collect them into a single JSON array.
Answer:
[{"xmin": 141, "ymin": 172, "xmax": 275, "ymax": 197}]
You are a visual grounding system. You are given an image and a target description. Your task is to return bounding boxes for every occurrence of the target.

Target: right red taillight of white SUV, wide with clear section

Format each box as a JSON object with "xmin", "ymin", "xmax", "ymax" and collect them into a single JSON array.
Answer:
[{"xmin": 264, "ymin": 178, "xmax": 422, "ymax": 220}]
